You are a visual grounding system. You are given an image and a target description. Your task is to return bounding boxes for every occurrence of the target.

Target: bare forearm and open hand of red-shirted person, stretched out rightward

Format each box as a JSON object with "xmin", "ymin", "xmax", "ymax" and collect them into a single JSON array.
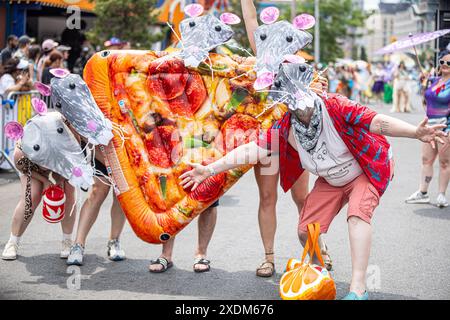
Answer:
[{"xmin": 370, "ymin": 114, "xmax": 447, "ymax": 147}]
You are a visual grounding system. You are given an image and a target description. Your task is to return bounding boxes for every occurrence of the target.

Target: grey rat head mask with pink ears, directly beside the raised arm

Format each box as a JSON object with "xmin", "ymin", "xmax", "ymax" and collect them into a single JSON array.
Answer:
[{"xmin": 254, "ymin": 7, "xmax": 315, "ymax": 89}]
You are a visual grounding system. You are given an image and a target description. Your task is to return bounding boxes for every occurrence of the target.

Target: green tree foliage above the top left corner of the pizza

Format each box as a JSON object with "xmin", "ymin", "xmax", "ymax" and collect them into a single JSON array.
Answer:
[{"xmin": 88, "ymin": 0, "xmax": 166, "ymax": 49}]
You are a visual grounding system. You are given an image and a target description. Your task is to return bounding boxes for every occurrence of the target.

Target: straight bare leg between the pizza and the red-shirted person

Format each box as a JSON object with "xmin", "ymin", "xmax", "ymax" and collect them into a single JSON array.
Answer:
[{"xmin": 255, "ymin": 164, "xmax": 279, "ymax": 272}]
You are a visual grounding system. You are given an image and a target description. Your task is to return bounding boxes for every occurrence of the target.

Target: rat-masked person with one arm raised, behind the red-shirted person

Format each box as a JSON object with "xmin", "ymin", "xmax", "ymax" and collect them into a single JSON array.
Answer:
[{"xmin": 241, "ymin": 0, "xmax": 332, "ymax": 277}]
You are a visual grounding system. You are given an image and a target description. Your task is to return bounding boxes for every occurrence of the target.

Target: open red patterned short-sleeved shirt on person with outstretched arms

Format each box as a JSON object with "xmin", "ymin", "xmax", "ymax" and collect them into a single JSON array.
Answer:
[{"xmin": 258, "ymin": 94, "xmax": 393, "ymax": 196}]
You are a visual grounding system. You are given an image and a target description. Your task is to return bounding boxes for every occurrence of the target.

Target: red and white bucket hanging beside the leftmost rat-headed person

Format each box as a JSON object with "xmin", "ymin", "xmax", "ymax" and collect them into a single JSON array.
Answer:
[{"xmin": 42, "ymin": 186, "xmax": 66, "ymax": 223}]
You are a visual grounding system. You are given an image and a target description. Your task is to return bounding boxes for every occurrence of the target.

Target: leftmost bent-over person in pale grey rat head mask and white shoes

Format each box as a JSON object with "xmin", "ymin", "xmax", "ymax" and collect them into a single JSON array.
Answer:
[{"xmin": 2, "ymin": 110, "xmax": 96, "ymax": 260}]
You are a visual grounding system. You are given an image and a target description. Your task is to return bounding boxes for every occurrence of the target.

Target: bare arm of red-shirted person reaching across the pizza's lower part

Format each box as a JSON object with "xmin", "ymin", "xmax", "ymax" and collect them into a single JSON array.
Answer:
[{"xmin": 180, "ymin": 142, "xmax": 270, "ymax": 191}]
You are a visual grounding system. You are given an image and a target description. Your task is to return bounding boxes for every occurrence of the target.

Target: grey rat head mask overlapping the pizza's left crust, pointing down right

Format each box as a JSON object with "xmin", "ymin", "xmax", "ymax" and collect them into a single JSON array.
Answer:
[{"xmin": 36, "ymin": 69, "xmax": 113, "ymax": 145}]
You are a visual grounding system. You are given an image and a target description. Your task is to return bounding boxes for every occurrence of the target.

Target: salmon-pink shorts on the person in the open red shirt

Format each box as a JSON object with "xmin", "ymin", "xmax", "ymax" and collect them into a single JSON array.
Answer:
[{"xmin": 298, "ymin": 174, "xmax": 380, "ymax": 233}]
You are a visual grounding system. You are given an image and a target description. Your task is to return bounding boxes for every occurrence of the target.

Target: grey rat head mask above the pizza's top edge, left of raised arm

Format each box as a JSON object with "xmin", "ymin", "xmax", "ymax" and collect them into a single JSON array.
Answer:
[{"xmin": 180, "ymin": 4, "xmax": 241, "ymax": 68}]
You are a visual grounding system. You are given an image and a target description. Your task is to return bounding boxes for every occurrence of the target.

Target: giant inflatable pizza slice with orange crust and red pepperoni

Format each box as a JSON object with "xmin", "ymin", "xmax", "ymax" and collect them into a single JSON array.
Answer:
[{"xmin": 84, "ymin": 51, "xmax": 286, "ymax": 243}]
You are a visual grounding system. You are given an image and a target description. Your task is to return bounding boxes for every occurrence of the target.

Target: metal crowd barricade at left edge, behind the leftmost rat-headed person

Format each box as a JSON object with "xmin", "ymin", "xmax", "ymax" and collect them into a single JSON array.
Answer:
[{"xmin": 0, "ymin": 91, "xmax": 41, "ymax": 174}]
